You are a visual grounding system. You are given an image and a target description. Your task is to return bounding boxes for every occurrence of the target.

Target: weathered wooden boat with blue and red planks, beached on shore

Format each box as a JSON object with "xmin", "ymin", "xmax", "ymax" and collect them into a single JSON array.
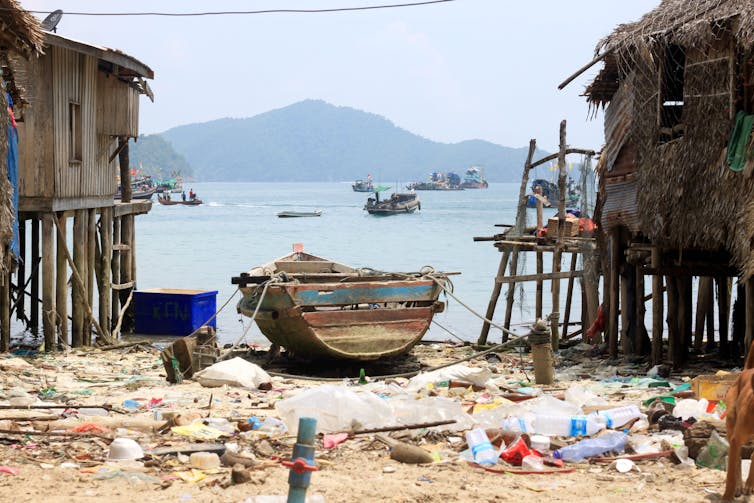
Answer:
[{"xmin": 232, "ymin": 251, "xmax": 447, "ymax": 360}]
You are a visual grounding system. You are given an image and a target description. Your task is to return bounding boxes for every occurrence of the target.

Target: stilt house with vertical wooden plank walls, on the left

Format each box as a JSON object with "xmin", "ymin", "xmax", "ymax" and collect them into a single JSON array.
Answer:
[{"xmin": 0, "ymin": 22, "xmax": 154, "ymax": 350}]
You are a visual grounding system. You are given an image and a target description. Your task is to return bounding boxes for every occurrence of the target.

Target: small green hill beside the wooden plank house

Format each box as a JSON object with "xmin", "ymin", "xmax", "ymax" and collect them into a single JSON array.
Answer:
[{"xmin": 128, "ymin": 135, "xmax": 193, "ymax": 179}]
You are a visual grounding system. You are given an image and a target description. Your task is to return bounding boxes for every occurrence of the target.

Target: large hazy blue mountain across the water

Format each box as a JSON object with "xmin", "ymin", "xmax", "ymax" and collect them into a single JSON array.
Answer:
[{"xmin": 154, "ymin": 100, "xmax": 540, "ymax": 182}]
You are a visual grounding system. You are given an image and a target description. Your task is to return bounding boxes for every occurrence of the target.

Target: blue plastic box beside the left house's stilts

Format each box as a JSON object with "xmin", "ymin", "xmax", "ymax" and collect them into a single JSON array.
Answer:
[{"xmin": 134, "ymin": 288, "xmax": 217, "ymax": 336}]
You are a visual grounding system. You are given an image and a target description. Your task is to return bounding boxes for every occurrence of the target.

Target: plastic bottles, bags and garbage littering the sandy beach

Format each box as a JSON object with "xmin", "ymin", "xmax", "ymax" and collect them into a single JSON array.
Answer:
[{"xmin": 0, "ymin": 342, "xmax": 736, "ymax": 500}]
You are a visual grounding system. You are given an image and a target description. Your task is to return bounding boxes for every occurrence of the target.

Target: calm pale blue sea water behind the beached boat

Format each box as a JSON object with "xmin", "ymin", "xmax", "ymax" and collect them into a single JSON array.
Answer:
[{"xmin": 14, "ymin": 182, "xmax": 581, "ymax": 345}]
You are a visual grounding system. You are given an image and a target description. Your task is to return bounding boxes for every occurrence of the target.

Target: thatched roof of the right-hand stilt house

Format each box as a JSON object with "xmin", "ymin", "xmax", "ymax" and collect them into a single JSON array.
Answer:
[{"xmin": 585, "ymin": 0, "xmax": 754, "ymax": 105}]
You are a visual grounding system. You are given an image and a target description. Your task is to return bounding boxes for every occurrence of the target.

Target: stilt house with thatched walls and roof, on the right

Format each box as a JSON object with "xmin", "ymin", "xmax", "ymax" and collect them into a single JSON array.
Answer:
[{"xmin": 563, "ymin": 0, "xmax": 754, "ymax": 365}]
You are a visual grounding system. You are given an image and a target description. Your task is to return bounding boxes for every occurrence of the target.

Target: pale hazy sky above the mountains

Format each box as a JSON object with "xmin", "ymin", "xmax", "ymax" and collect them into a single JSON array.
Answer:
[{"xmin": 21, "ymin": 0, "xmax": 659, "ymax": 150}]
